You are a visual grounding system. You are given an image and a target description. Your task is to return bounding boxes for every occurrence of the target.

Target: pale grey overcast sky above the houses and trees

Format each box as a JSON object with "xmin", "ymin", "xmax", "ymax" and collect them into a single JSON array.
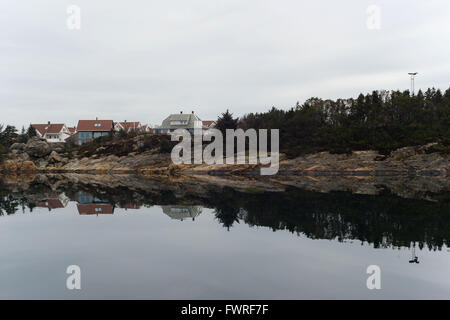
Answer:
[{"xmin": 0, "ymin": 0, "xmax": 450, "ymax": 128}]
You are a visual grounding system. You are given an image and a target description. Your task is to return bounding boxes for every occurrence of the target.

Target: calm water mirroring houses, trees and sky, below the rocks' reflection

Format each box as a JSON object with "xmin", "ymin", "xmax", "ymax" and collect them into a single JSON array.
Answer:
[{"xmin": 0, "ymin": 179, "xmax": 450, "ymax": 299}]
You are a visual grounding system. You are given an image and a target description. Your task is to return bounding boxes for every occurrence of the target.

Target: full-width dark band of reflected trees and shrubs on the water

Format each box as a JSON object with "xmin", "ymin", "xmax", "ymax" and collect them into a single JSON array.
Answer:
[{"xmin": 0, "ymin": 179, "xmax": 450, "ymax": 249}]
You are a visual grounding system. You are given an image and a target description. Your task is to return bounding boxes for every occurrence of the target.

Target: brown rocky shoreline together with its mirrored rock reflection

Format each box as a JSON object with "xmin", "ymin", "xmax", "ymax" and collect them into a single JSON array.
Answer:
[{"xmin": 0, "ymin": 139, "xmax": 450, "ymax": 200}]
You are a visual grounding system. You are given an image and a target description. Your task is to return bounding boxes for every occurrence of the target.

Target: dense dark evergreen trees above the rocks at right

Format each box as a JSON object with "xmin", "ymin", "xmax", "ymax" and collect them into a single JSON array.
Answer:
[{"xmin": 216, "ymin": 88, "xmax": 450, "ymax": 156}]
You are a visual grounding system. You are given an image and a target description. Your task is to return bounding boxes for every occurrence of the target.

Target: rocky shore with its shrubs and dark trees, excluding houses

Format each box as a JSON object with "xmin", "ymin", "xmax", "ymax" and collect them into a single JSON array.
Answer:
[{"xmin": 0, "ymin": 88, "xmax": 450, "ymax": 179}]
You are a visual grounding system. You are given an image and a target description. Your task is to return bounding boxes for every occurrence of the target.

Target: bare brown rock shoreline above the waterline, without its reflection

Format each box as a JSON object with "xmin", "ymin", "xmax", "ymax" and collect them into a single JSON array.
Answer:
[{"xmin": 0, "ymin": 138, "xmax": 450, "ymax": 179}]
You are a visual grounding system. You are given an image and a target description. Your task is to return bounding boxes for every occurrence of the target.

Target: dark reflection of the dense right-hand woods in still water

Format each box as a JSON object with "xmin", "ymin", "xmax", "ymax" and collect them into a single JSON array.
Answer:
[{"xmin": 222, "ymin": 190, "xmax": 450, "ymax": 249}]
